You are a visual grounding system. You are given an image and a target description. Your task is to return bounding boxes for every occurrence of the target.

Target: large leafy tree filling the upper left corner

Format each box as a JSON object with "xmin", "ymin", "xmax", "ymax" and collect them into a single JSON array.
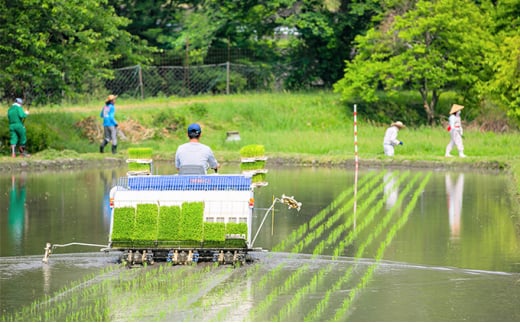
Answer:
[{"xmin": 0, "ymin": 0, "xmax": 150, "ymax": 103}]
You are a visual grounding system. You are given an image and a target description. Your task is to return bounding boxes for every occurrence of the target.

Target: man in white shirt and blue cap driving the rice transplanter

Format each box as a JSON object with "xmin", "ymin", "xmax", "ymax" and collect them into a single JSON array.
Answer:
[{"xmin": 175, "ymin": 123, "xmax": 220, "ymax": 174}]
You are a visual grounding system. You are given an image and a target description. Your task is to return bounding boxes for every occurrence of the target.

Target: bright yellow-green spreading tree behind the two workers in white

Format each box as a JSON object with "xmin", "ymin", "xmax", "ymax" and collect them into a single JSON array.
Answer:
[{"xmin": 335, "ymin": 0, "xmax": 493, "ymax": 124}]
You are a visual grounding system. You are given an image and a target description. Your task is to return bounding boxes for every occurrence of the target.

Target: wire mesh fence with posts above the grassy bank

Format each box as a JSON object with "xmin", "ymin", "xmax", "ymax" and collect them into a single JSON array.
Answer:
[{"xmin": 106, "ymin": 62, "xmax": 274, "ymax": 98}]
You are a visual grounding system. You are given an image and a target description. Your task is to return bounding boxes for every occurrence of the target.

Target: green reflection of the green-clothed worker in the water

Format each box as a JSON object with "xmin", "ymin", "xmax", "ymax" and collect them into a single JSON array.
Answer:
[{"xmin": 8, "ymin": 173, "xmax": 26, "ymax": 252}]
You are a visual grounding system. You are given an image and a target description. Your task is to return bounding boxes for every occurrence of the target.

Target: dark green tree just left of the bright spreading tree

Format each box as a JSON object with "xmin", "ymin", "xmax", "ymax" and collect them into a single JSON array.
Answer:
[{"xmin": 277, "ymin": 0, "xmax": 381, "ymax": 88}]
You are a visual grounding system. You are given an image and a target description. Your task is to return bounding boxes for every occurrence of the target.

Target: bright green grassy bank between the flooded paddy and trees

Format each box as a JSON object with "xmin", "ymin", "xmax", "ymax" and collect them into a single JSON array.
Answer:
[{"xmin": 0, "ymin": 93, "xmax": 520, "ymax": 196}]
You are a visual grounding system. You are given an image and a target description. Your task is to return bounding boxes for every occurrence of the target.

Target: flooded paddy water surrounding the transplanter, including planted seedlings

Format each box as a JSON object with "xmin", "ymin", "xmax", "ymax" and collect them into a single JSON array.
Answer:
[{"xmin": 0, "ymin": 163, "xmax": 520, "ymax": 321}]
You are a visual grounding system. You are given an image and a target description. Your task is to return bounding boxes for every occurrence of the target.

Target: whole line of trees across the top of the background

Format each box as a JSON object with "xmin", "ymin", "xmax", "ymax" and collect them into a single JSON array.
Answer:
[{"xmin": 0, "ymin": 0, "xmax": 520, "ymax": 124}]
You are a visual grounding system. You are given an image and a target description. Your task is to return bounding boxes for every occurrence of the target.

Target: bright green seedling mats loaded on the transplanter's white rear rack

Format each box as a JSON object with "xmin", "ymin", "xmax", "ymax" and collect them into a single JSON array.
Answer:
[{"xmin": 111, "ymin": 202, "xmax": 247, "ymax": 248}]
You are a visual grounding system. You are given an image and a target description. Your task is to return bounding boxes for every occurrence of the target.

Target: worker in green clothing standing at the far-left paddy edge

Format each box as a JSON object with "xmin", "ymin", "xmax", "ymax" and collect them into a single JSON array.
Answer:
[{"xmin": 7, "ymin": 98, "xmax": 30, "ymax": 157}]
